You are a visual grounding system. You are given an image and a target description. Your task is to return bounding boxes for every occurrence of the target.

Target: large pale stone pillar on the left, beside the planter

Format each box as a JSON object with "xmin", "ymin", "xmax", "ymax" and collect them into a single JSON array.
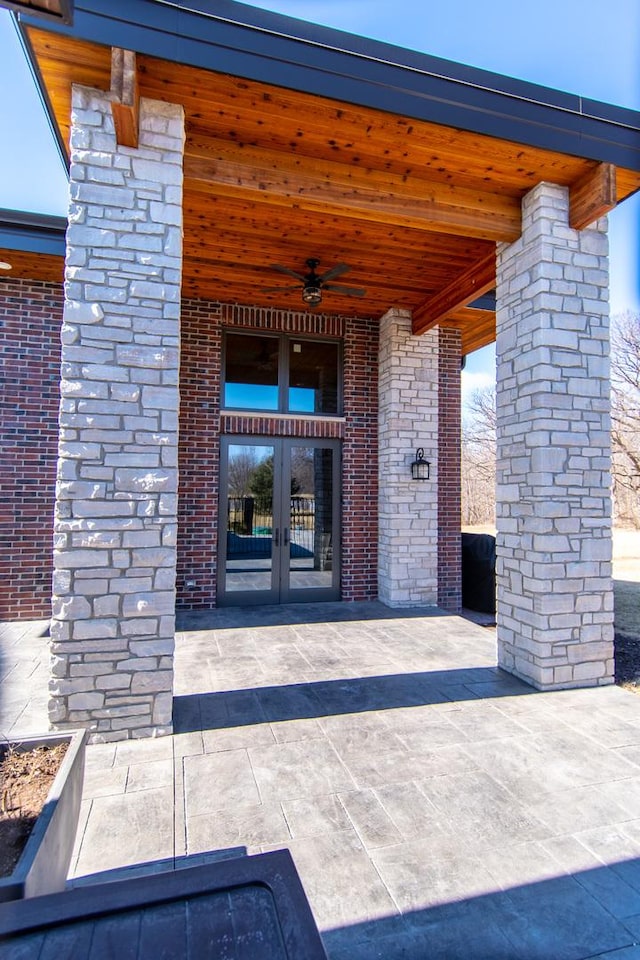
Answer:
[{"xmin": 50, "ymin": 88, "xmax": 184, "ymax": 740}]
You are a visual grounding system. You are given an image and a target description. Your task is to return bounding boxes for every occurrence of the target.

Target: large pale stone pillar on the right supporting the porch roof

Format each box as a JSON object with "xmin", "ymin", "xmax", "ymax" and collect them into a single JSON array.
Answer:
[{"xmin": 497, "ymin": 183, "xmax": 613, "ymax": 689}]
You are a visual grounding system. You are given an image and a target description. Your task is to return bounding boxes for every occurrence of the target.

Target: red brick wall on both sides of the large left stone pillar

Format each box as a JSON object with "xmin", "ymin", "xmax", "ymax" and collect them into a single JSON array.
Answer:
[{"xmin": 0, "ymin": 280, "xmax": 378, "ymax": 619}]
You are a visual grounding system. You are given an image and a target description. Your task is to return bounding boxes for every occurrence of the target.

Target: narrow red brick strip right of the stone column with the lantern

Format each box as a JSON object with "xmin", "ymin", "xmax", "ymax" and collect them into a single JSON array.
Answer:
[{"xmin": 438, "ymin": 327, "xmax": 462, "ymax": 612}]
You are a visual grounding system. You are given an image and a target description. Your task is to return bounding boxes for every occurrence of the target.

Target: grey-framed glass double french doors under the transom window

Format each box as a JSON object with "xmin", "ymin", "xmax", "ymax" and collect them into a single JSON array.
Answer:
[{"xmin": 218, "ymin": 437, "xmax": 340, "ymax": 604}]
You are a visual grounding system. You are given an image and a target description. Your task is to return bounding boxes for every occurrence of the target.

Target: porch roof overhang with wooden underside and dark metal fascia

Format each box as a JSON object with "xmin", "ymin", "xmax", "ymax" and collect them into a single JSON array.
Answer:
[{"xmin": 5, "ymin": 0, "xmax": 640, "ymax": 352}]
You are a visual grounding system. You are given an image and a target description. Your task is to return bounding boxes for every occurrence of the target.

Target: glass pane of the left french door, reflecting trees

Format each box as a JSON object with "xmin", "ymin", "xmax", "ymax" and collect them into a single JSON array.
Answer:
[{"xmin": 225, "ymin": 444, "xmax": 274, "ymax": 591}]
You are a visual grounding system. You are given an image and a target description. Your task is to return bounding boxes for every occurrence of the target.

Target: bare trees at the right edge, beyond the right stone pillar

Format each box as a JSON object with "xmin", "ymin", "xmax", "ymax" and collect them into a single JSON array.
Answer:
[{"xmin": 611, "ymin": 313, "xmax": 640, "ymax": 527}]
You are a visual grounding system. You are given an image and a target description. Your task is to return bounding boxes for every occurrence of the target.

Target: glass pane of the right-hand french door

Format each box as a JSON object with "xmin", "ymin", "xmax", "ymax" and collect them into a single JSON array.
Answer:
[{"xmin": 289, "ymin": 447, "xmax": 333, "ymax": 590}]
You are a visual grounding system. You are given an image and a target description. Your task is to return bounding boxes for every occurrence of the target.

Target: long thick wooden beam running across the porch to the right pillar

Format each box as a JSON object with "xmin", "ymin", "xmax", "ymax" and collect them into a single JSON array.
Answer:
[{"xmin": 184, "ymin": 138, "xmax": 521, "ymax": 242}]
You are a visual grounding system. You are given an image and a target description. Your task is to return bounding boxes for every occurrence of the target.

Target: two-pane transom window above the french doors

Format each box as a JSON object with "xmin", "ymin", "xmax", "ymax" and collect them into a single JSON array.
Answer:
[{"xmin": 222, "ymin": 333, "xmax": 342, "ymax": 414}]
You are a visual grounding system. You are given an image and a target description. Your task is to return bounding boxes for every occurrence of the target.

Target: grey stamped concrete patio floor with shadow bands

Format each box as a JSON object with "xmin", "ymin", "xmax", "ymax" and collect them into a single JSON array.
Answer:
[{"xmin": 0, "ymin": 603, "xmax": 640, "ymax": 960}]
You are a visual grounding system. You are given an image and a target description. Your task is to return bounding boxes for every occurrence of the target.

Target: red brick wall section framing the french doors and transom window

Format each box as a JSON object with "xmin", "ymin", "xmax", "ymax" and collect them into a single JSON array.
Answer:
[{"xmin": 177, "ymin": 300, "xmax": 378, "ymax": 609}]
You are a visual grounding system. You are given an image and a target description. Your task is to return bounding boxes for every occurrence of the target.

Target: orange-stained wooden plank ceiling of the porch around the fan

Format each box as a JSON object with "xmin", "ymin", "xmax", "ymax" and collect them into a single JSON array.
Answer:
[{"xmin": 22, "ymin": 29, "xmax": 640, "ymax": 352}]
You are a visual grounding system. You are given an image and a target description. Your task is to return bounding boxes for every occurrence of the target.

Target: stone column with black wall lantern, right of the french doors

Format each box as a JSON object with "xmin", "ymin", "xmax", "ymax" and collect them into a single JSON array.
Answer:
[{"xmin": 378, "ymin": 309, "xmax": 438, "ymax": 607}]
